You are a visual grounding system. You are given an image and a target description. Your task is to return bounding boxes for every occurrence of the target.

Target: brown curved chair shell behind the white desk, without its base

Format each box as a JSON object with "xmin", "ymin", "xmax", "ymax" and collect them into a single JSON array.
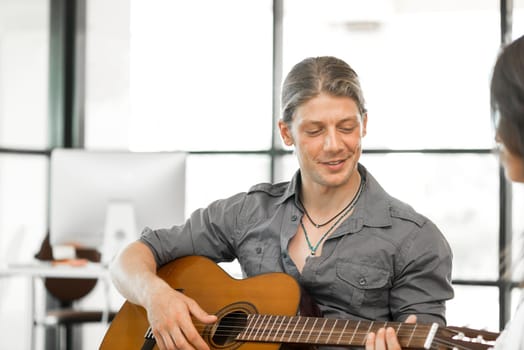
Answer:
[{"xmin": 35, "ymin": 233, "xmax": 101, "ymax": 305}]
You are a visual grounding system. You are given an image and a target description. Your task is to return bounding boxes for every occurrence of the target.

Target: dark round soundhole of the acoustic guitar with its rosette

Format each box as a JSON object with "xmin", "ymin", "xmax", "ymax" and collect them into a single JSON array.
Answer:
[{"xmin": 204, "ymin": 302, "xmax": 257, "ymax": 350}]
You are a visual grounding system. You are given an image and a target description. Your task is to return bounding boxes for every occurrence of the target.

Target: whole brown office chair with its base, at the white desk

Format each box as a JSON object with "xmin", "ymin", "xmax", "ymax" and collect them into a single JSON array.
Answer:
[{"xmin": 33, "ymin": 234, "xmax": 116, "ymax": 350}]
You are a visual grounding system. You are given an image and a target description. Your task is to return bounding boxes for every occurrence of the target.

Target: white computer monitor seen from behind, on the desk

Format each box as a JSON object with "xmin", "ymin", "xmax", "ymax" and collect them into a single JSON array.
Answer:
[{"xmin": 49, "ymin": 149, "xmax": 186, "ymax": 261}]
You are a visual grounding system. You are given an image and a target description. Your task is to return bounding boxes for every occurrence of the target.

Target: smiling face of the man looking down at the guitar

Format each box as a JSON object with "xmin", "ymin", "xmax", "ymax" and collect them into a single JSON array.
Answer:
[{"xmin": 279, "ymin": 94, "xmax": 367, "ymax": 190}]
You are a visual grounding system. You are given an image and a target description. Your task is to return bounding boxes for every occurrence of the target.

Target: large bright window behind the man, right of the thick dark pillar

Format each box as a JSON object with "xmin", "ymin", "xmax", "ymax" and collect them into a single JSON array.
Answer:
[{"xmin": 85, "ymin": 0, "xmax": 522, "ymax": 327}]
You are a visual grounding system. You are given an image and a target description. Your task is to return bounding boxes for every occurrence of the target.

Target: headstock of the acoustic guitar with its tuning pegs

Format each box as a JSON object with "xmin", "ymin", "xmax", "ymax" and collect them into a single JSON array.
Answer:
[{"xmin": 433, "ymin": 326, "xmax": 499, "ymax": 350}]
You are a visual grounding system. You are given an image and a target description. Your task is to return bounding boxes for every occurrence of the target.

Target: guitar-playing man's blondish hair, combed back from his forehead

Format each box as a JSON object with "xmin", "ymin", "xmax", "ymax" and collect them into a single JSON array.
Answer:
[{"xmin": 281, "ymin": 56, "xmax": 366, "ymax": 124}]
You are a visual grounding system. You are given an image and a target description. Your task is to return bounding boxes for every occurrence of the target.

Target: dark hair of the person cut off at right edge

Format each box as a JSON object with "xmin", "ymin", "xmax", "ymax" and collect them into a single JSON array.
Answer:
[{"xmin": 490, "ymin": 36, "xmax": 524, "ymax": 157}]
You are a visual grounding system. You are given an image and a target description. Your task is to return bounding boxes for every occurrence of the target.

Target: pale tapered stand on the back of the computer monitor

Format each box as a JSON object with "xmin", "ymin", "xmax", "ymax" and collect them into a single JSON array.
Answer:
[{"xmin": 102, "ymin": 201, "xmax": 137, "ymax": 263}]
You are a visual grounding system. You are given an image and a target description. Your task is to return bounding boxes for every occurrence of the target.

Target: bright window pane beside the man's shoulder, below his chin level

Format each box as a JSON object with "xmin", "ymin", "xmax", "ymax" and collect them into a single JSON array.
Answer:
[{"xmin": 362, "ymin": 154, "xmax": 499, "ymax": 280}]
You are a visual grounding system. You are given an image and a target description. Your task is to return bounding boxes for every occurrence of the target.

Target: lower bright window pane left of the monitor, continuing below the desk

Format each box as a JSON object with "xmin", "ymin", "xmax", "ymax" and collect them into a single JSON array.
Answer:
[{"xmin": 0, "ymin": 155, "xmax": 47, "ymax": 349}]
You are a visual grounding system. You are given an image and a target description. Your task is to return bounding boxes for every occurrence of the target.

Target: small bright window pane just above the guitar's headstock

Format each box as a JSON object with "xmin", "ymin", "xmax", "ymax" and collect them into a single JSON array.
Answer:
[{"xmin": 446, "ymin": 285, "xmax": 499, "ymax": 332}]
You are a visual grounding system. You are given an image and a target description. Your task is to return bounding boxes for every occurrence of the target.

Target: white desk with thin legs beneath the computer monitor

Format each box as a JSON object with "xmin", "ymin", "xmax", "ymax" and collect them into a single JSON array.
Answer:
[{"xmin": 0, "ymin": 260, "xmax": 110, "ymax": 349}]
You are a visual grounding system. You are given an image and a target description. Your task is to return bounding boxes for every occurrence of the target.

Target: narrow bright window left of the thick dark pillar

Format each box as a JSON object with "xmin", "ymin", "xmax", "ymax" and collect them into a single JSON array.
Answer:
[{"xmin": 0, "ymin": 0, "xmax": 49, "ymax": 348}]
